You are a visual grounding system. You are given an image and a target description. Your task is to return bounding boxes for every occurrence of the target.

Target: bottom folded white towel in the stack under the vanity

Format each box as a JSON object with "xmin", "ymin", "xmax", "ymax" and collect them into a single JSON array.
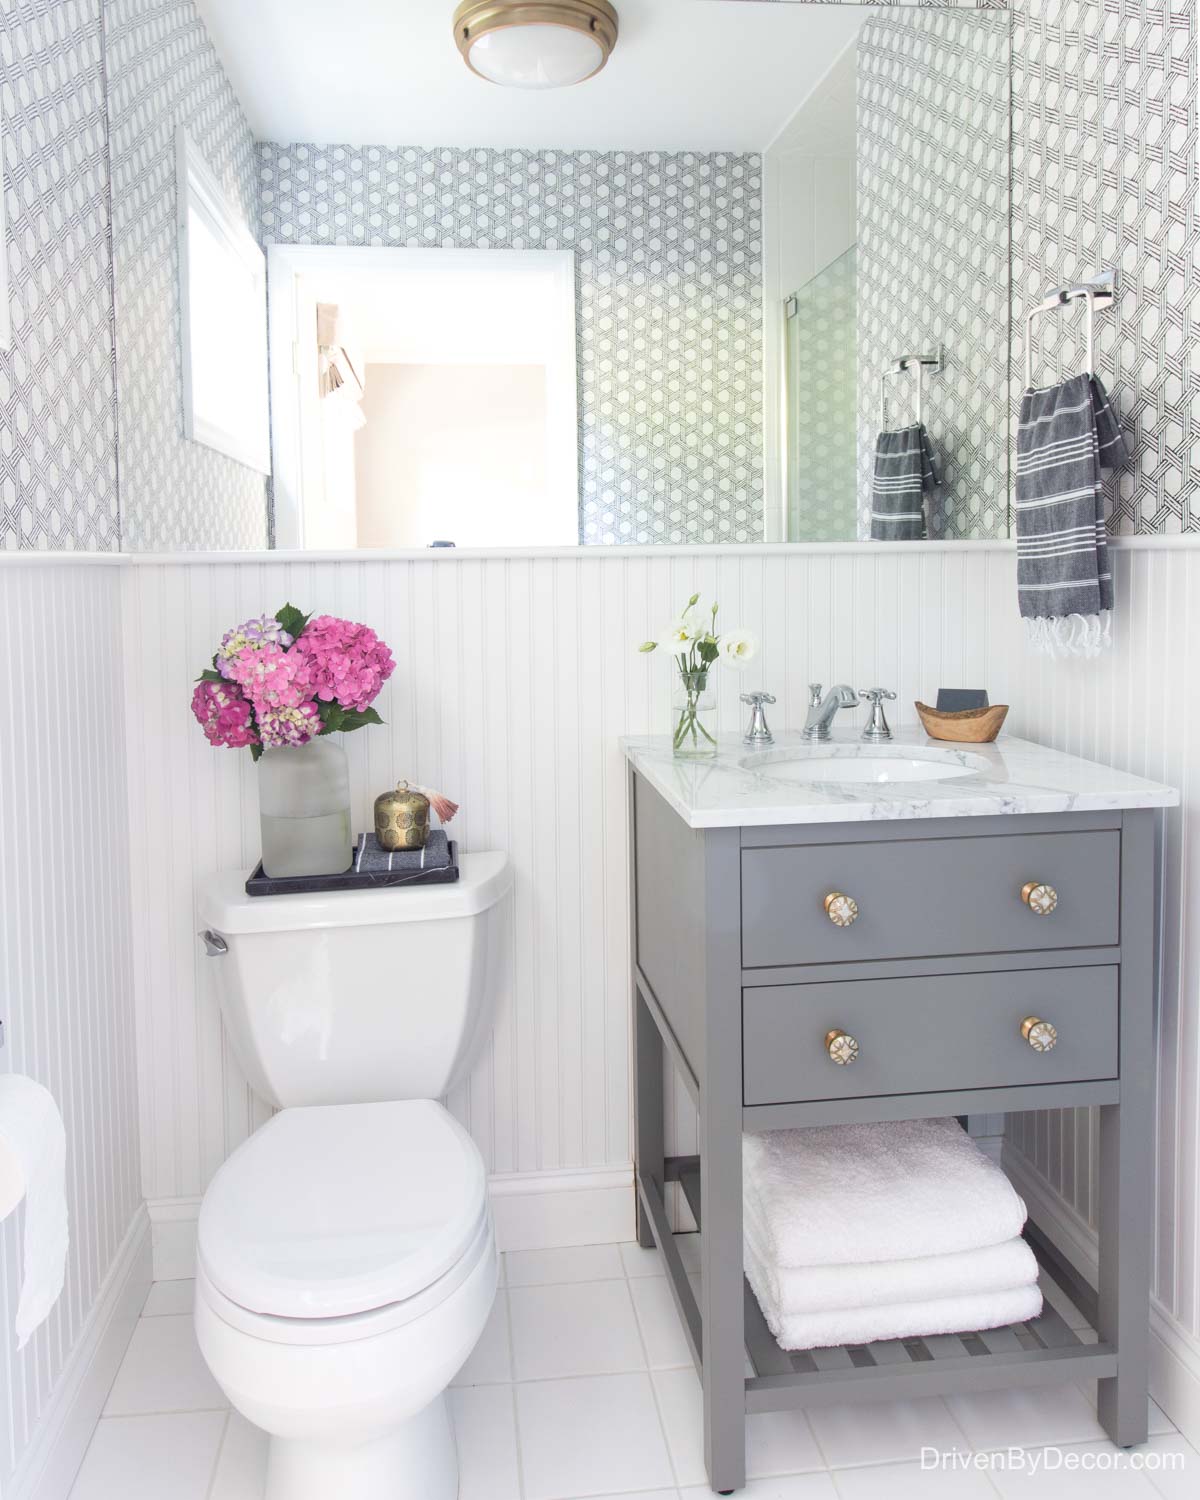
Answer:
[{"xmin": 747, "ymin": 1268, "xmax": 1041, "ymax": 1349}]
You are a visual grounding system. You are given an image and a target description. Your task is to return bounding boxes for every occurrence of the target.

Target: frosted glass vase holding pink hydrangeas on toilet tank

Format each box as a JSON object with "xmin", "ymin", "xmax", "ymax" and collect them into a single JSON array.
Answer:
[{"xmin": 258, "ymin": 738, "xmax": 354, "ymax": 881}]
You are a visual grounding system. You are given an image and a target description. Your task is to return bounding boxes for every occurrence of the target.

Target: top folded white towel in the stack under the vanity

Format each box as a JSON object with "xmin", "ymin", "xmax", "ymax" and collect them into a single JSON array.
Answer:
[{"xmin": 743, "ymin": 1119, "xmax": 1026, "ymax": 1268}]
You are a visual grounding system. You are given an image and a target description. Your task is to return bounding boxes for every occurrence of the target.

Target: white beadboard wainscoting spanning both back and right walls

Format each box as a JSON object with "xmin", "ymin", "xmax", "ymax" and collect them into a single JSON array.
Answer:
[{"xmin": 114, "ymin": 543, "xmax": 1200, "ymax": 1431}]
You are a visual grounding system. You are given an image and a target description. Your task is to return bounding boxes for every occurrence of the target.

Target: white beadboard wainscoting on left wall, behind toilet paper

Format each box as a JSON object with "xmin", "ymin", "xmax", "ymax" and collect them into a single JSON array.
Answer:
[{"xmin": 0, "ymin": 560, "xmax": 150, "ymax": 1500}]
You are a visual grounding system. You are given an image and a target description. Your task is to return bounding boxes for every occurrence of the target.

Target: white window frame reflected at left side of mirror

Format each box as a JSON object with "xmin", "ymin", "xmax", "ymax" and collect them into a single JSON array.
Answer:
[{"xmin": 176, "ymin": 129, "xmax": 272, "ymax": 474}]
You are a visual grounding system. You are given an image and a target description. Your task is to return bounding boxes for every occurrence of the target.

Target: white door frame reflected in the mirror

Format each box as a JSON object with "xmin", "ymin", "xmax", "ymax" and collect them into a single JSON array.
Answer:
[{"xmin": 267, "ymin": 245, "xmax": 579, "ymax": 549}]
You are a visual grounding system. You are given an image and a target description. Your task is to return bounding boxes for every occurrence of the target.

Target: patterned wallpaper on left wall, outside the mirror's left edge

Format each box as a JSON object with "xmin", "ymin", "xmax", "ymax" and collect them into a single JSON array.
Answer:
[{"xmin": 0, "ymin": 0, "xmax": 120, "ymax": 552}]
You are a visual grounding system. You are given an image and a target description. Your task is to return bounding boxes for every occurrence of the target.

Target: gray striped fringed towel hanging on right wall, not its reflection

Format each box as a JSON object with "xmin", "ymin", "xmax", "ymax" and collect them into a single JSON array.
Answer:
[{"xmin": 1017, "ymin": 375, "xmax": 1130, "ymax": 657}]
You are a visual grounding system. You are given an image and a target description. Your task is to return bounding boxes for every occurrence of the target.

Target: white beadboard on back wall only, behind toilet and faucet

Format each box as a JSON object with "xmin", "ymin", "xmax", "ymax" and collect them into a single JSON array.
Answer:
[{"xmin": 117, "ymin": 549, "xmax": 1019, "ymax": 1224}]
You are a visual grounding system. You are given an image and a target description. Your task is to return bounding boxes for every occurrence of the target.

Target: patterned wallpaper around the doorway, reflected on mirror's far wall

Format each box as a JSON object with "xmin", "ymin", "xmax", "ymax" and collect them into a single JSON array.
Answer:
[{"xmin": 260, "ymin": 144, "xmax": 762, "ymax": 543}]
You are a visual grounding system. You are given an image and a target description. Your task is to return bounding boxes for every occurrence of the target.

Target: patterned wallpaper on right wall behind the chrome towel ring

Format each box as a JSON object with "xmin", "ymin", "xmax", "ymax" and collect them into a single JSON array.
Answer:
[{"xmin": 1013, "ymin": 0, "xmax": 1200, "ymax": 534}]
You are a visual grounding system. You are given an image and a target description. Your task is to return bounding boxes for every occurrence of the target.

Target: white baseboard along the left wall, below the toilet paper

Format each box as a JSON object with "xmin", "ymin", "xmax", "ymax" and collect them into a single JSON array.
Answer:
[{"xmin": 8, "ymin": 1208, "xmax": 152, "ymax": 1500}]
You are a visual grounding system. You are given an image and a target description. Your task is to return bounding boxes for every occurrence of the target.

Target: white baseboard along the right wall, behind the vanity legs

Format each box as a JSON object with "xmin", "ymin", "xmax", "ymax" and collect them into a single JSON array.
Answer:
[{"xmin": 1004, "ymin": 1143, "xmax": 1200, "ymax": 1445}]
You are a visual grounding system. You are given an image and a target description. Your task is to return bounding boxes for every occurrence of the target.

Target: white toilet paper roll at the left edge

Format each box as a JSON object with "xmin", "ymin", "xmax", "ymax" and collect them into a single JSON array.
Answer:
[{"xmin": 0, "ymin": 1073, "xmax": 68, "ymax": 1349}]
